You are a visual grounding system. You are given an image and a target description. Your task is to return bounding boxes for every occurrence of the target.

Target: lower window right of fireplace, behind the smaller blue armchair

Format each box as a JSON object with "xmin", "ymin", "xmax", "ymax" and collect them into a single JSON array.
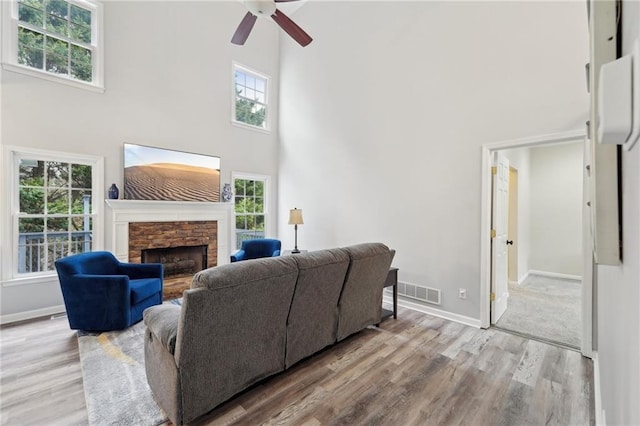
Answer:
[{"xmin": 234, "ymin": 177, "xmax": 267, "ymax": 249}]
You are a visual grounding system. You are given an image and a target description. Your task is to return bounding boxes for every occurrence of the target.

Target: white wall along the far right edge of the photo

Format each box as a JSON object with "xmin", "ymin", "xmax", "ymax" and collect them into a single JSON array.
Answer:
[{"xmin": 596, "ymin": 0, "xmax": 640, "ymax": 425}]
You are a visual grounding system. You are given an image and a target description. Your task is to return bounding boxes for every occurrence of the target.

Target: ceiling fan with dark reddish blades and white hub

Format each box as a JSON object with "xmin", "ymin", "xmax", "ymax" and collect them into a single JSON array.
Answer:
[{"xmin": 231, "ymin": 0, "xmax": 313, "ymax": 47}]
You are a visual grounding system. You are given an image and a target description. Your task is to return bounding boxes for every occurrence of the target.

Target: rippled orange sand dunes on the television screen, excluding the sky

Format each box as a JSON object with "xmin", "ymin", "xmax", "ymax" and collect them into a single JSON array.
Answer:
[{"xmin": 124, "ymin": 163, "xmax": 220, "ymax": 202}]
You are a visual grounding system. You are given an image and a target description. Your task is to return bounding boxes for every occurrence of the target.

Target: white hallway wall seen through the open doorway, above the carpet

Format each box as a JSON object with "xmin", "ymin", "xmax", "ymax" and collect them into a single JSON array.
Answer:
[{"xmin": 529, "ymin": 142, "xmax": 583, "ymax": 277}]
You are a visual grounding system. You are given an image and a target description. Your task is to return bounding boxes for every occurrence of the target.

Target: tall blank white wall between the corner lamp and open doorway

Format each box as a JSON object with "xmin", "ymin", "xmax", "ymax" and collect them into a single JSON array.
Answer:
[{"xmin": 279, "ymin": 1, "xmax": 588, "ymax": 319}]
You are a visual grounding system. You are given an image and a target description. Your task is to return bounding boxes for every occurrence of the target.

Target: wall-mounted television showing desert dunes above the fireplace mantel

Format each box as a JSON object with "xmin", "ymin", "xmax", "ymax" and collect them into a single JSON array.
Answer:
[{"xmin": 124, "ymin": 143, "xmax": 220, "ymax": 202}]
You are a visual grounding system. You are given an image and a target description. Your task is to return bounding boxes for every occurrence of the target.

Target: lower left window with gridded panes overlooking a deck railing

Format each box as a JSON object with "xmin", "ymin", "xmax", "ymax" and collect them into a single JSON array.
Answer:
[{"xmin": 12, "ymin": 148, "xmax": 102, "ymax": 274}]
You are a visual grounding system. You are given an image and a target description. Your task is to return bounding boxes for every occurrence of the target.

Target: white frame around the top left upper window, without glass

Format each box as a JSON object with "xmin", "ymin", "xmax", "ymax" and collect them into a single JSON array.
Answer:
[{"xmin": 0, "ymin": 0, "xmax": 104, "ymax": 93}]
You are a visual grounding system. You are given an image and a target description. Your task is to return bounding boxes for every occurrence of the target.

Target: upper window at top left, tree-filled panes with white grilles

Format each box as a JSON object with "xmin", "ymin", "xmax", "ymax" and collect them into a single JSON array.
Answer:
[{"xmin": 3, "ymin": 0, "xmax": 102, "ymax": 90}]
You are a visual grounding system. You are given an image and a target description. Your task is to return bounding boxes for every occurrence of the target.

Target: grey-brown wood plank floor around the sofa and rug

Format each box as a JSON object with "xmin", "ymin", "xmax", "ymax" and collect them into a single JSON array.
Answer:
[{"xmin": 0, "ymin": 309, "xmax": 595, "ymax": 425}]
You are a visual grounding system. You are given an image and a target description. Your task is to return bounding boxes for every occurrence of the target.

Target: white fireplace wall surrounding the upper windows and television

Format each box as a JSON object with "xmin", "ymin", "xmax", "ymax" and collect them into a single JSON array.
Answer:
[{"xmin": 0, "ymin": 1, "xmax": 279, "ymax": 318}]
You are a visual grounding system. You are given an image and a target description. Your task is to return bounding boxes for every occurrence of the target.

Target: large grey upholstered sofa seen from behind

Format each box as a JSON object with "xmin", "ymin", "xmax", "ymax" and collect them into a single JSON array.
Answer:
[{"xmin": 144, "ymin": 243, "xmax": 394, "ymax": 425}]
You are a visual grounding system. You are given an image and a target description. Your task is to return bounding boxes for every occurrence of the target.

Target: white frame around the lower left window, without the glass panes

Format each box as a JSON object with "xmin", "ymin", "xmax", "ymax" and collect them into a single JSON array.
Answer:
[{"xmin": 2, "ymin": 146, "xmax": 104, "ymax": 286}]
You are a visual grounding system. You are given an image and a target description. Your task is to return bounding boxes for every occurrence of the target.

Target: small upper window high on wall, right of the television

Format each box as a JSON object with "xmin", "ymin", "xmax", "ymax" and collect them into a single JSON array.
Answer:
[{"xmin": 233, "ymin": 65, "xmax": 269, "ymax": 130}]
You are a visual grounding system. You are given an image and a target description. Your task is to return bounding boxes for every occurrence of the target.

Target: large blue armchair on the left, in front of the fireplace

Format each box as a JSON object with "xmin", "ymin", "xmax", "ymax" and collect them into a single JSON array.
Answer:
[{"xmin": 55, "ymin": 251, "xmax": 163, "ymax": 331}]
